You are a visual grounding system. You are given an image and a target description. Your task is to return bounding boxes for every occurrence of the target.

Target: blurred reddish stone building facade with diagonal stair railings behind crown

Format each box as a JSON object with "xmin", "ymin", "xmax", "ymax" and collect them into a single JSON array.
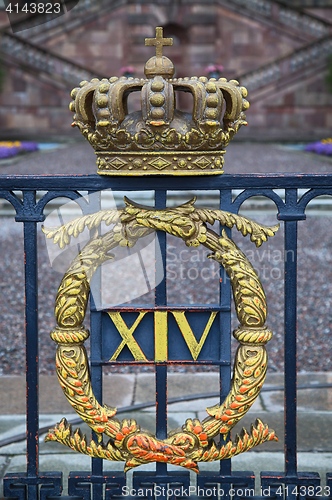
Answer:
[{"xmin": 0, "ymin": 0, "xmax": 332, "ymax": 140}]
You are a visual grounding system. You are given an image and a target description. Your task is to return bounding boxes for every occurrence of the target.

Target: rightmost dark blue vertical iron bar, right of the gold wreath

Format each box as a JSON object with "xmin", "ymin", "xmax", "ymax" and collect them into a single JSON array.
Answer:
[{"xmin": 284, "ymin": 189, "xmax": 297, "ymax": 475}]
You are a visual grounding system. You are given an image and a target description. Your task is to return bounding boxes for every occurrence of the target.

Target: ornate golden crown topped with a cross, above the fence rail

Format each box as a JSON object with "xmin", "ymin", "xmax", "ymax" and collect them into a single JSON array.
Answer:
[{"xmin": 69, "ymin": 27, "xmax": 249, "ymax": 175}]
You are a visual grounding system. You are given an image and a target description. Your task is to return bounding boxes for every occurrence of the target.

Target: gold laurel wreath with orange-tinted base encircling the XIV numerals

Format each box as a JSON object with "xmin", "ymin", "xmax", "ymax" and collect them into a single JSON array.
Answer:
[{"xmin": 43, "ymin": 198, "xmax": 279, "ymax": 472}]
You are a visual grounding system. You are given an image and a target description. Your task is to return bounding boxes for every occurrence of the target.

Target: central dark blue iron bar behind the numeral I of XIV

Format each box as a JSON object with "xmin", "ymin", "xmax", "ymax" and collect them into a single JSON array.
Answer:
[{"xmin": 155, "ymin": 190, "xmax": 167, "ymax": 475}]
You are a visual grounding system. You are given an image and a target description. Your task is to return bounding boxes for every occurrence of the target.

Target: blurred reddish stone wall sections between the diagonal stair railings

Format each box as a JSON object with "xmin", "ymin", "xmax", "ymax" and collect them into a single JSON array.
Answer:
[{"xmin": 0, "ymin": 0, "xmax": 332, "ymax": 139}]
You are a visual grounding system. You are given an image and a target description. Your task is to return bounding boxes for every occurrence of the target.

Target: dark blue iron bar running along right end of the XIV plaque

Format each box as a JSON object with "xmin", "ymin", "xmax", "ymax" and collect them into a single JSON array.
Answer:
[{"xmin": 219, "ymin": 190, "xmax": 232, "ymax": 476}]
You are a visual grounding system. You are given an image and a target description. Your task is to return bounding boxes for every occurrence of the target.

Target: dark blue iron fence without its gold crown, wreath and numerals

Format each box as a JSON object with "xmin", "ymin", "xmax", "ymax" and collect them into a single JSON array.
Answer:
[{"xmin": 0, "ymin": 174, "xmax": 332, "ymax": 500}]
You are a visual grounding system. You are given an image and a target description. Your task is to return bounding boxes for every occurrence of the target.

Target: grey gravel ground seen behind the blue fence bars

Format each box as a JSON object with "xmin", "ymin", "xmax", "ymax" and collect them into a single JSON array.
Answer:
[{"xmin": 0, "ymin": 143, "xmax": 332, "ymax": 374}]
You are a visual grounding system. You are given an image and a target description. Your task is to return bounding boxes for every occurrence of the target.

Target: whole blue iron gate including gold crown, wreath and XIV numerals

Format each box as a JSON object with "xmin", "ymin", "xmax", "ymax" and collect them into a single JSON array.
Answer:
[{"xmin": 0, "ymin": 27, "xmax": 332, "ymax": 500}]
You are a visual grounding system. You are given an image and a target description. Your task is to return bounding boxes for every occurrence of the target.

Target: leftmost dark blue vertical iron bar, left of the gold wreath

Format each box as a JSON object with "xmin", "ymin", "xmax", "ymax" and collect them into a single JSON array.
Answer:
[{"xmin": 23, "ymin": 191, "xmax": 39, "ymax": 478}]
